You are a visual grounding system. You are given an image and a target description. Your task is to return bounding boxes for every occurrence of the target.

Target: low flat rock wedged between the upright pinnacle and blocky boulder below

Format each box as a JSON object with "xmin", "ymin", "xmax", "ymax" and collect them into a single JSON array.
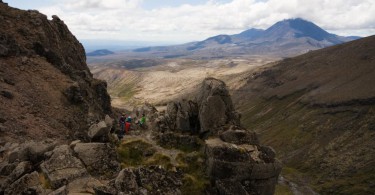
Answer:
[{"xmin": 220, "ymin": 129, "xmax": 260, "ymax": 145}]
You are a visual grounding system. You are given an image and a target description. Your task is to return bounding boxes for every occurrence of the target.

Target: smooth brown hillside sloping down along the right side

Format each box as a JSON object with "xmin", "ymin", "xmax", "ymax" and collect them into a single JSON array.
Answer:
[{"xmin": 234, "ymin": 36, "xmax": 375, "ymax": 194}]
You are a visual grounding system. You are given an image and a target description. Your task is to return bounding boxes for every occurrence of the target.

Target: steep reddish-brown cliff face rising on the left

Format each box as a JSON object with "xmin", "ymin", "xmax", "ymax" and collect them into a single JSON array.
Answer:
[{"xmin": 0, "ymin": 2, "xmax": 111, "ymax": 142}]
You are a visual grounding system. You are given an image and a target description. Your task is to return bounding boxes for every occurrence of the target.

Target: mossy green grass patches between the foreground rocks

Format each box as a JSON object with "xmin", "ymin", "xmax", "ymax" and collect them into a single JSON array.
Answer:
[{"xmin": 117, "ymin": 139, "xmax": 209, "ymax": 194}]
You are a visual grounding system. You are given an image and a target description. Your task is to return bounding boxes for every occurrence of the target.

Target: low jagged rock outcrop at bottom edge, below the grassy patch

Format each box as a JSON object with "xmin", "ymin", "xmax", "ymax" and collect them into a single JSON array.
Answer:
[{"xmin": 95, "ymin": 166, "xmax": 182, "ymax": 195}]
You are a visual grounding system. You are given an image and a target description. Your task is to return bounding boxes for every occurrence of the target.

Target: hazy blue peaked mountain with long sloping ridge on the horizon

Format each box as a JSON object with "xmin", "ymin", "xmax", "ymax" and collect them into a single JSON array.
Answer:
[{"xmin": 133, "ymin": 18, "xmax": 359, "ymax": 58}]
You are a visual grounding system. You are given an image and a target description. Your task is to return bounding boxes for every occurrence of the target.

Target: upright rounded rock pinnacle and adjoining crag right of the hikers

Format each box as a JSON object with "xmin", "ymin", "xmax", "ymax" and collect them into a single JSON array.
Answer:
[{"xmin": 157, "ymin": 78, "xmax": 240, "ymax": 135}]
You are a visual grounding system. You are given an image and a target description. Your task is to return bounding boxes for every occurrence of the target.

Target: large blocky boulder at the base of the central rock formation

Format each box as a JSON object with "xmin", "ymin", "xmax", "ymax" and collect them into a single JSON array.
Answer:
[{"xmin": 205, "ymin": 138, "xmax": 281, "ymax": 195}]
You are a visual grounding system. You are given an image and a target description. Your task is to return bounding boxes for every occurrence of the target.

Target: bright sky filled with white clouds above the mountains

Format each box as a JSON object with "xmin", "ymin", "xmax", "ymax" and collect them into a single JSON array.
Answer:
[{"xmin": 3, "ymin": 0, "xmax": 375, "ymax": 43}]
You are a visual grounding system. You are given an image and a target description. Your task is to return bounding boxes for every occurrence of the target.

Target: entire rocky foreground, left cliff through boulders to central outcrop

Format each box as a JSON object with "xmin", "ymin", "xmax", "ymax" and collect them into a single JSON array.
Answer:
[{"xmin": 0, "ymin": 1, "xmax": 282, "ymax": 195}]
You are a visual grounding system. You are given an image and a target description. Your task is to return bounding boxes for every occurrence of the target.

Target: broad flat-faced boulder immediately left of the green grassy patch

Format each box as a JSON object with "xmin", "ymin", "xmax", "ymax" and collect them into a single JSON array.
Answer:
[{"xmin": 74, "ymin": 143, "xmax": 120, "ymax": 177}]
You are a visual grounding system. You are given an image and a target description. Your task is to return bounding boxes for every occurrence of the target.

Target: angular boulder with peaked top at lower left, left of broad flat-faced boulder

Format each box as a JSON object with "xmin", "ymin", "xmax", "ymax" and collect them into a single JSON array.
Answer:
[{"xmin": 40, "ymin": 145, "xmax": 87, "ymax": 189}]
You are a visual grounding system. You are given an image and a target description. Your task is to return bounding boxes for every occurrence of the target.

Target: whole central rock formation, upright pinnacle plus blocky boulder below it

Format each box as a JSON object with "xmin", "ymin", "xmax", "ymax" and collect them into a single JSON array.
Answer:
[{"xmin": 153, "ymin": 78, "xmax": 281, "ymax": 194}]
